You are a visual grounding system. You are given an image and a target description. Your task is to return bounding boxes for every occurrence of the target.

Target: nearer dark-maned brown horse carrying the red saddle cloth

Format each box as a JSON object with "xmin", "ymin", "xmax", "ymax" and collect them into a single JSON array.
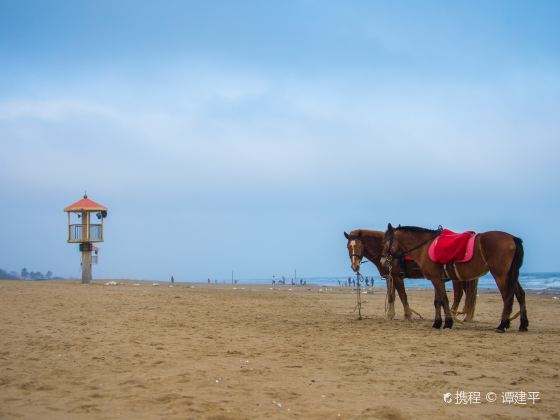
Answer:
[{"xmin": 382, "ymin": 223, "xmax": 529, "ymax": 332}]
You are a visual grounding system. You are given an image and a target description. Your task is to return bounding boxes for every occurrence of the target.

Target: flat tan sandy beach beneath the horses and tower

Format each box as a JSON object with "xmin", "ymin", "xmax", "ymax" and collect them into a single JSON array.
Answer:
[{"xmin": 0, "ymin": 280, "xmax": 560, "ymax": 419}]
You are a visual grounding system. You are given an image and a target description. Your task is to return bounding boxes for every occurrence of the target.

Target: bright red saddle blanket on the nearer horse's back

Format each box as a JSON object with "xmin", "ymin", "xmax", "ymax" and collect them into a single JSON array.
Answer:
[{"xmin": 428, "ymin": 229, "xmax": 477, "ymax": 264}]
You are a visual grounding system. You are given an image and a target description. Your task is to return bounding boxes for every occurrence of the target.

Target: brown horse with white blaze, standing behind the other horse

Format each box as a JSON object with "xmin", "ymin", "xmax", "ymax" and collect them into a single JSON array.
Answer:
[{"xmin": 344, "ymin": 229, "xmax": 478, "ymax": 321}]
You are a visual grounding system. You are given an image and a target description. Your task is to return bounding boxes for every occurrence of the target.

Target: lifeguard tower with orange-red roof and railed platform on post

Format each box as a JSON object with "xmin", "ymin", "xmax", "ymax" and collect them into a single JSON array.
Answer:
[{"xmin": 64, "ymin": 194, "xmax": 107, "ymax": 284}]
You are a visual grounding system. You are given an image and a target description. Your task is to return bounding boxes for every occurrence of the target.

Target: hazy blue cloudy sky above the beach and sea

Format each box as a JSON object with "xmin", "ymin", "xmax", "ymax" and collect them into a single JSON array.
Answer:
[{"xmin": 0, "ymin": 0, "xmax": 560, "ymax": 281}]
